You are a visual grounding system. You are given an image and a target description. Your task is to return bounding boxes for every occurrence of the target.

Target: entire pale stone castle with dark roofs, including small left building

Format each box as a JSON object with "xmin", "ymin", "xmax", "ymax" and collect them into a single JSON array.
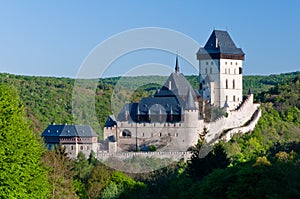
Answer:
[{"xmin": 42, "ymin": 30, "xmax": 261, "ymax": 157}]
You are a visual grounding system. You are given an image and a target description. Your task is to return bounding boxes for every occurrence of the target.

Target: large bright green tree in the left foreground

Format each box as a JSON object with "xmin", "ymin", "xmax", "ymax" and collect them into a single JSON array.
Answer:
[{"xmin": 0, "ymin": 84, "xmax": 49, "ymax": 198}]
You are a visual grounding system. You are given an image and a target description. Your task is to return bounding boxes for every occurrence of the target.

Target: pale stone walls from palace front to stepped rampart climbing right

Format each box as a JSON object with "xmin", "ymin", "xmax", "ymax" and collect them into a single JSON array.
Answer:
[{"xmin": 104, "ymin": 94, "xmax": 261, "ymax": 152}]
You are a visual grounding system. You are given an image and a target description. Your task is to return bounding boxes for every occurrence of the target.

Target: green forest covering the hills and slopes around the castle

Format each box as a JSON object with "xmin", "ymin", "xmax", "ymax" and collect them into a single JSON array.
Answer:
[{"xmin": 0, "ymin": 72, "xmax": 300, "ymax": 198}]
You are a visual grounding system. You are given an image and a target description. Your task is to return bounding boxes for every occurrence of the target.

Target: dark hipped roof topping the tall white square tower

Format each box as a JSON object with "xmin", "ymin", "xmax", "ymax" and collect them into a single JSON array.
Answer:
[{"xmin": 197, "ymin": 30, "xmax": 244, "ymax": 55}]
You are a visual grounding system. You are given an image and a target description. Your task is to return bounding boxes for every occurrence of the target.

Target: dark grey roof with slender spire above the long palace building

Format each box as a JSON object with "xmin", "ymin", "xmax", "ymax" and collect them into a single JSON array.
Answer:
[{"xmin": 117, "ymin": 57, "xmax": 200, "ymax": 121}]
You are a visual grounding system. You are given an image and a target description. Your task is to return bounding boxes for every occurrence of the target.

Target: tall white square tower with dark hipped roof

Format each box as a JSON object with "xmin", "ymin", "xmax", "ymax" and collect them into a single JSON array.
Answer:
[{"xmin": 197, "ymin": 30, "xmax": 245, "ymax": 110}]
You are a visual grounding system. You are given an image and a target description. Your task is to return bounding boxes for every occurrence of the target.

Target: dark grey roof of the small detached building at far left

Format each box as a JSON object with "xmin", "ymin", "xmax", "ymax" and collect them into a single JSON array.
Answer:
[{"xmin": 42, "ymin": 124, "xmax": 98, "ymax": 137}]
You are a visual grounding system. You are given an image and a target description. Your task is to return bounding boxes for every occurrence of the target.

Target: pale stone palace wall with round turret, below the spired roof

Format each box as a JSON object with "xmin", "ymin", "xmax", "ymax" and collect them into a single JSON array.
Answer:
[{"xmin": 104, "ymin": 110, "xmax": 203, "ymax": 151}]
